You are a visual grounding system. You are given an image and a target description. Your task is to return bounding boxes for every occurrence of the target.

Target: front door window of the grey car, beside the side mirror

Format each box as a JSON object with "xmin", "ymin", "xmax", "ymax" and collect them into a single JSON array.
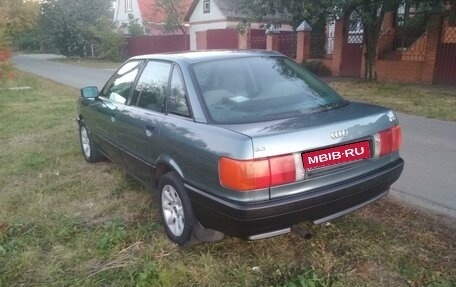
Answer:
[{"xmin": 102, "ymin": 61, "xmax": 141, "ymax": 104}]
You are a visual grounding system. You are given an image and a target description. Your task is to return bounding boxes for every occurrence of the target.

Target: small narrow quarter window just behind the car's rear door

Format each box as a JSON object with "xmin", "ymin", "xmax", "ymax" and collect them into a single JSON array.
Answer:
[{"xmin": 168, "ymin": 66, "xmax": 190, "ymax": 117}]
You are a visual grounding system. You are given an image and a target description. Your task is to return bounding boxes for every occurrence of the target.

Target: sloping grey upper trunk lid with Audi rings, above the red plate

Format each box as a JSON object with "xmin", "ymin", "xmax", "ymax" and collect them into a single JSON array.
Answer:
[{"xmin": 224, "ymin": 102, "xmax": 397, "ymax": 158}]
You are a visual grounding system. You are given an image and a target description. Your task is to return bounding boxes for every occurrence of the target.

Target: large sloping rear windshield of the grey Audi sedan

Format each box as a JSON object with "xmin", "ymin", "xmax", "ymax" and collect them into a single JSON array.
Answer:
[{"xmin": 192, "ymin": 57, "xmax": 345, "ymax": 124}]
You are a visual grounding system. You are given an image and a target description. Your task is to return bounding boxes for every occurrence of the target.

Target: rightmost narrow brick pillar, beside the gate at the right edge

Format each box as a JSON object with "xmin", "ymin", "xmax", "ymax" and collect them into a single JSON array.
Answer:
[{"xmin": 421, "ymin": 14, "xmax": 442, "ymax": 84}]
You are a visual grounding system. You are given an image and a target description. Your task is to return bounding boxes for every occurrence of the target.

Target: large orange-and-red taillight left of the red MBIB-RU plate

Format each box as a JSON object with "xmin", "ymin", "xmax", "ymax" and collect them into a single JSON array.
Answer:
[{"xmin": 219, "ymin": 154, "xmax": 304, "ymax": 191}]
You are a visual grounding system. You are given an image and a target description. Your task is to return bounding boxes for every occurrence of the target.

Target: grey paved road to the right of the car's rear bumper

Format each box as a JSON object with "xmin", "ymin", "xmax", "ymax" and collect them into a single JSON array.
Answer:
[{"xmin": 391, "ymin": 115, "xmax": 456, "ymax": 218}]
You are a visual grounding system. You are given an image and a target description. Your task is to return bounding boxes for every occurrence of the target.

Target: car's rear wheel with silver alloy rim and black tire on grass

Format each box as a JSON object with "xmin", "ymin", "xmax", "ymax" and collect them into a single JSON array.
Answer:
[{"xmin": 158, "ymin": 172, "xmax": 194, "ymax": 246}]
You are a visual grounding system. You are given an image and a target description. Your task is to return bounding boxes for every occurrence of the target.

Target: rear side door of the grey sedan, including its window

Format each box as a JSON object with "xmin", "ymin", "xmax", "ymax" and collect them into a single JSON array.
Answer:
[{"xmin": 117, "ymin": 60, "xmax": 172, "ymax": 184}]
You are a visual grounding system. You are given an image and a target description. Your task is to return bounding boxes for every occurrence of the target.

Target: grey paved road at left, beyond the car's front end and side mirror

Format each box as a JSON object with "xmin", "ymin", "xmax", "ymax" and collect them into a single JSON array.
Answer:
[{"xmin": 13, "ymin": 54, "xmax": 114, "ymax": 89}]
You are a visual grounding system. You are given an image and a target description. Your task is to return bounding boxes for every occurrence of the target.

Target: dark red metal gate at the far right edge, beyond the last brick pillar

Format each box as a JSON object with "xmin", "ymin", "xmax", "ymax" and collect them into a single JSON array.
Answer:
[{"xmin": 434, "ymin": 23, "xmax": 456, "ymax": 85}]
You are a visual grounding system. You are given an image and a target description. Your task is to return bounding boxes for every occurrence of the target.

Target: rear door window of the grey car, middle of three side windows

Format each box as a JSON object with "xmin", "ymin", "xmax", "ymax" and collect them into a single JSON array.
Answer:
[{"xmin": 131, "ymin": 61, "xmax": 171, "ymax": 112}]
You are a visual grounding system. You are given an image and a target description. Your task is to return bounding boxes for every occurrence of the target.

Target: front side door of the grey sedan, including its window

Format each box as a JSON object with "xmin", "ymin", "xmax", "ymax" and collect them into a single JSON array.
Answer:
[{"xmin": 88, "ymin": 60, "xmax": 142, "ymax": 164}]
